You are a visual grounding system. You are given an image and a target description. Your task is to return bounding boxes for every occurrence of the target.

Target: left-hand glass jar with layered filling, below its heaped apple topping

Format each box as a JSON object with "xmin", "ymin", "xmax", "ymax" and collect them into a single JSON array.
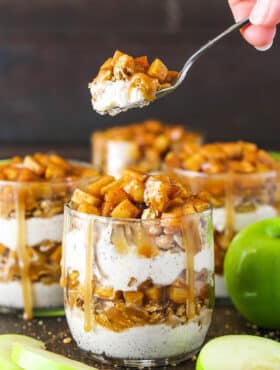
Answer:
[{"xmin": 0, "ymin": 162, "xmax": 97, "ymax": 319}]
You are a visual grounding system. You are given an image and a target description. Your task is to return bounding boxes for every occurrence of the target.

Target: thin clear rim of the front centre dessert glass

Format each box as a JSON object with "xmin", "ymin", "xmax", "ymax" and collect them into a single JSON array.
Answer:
[{"xmin": 64, "ymin": 202, "xmax": 213, "ymax": 224}]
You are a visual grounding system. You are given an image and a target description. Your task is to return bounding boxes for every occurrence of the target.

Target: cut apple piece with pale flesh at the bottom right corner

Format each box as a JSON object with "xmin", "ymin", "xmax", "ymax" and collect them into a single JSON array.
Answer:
[{"xmin": 196, "ymin": 335, "xmax": 280, "ymax": 370}]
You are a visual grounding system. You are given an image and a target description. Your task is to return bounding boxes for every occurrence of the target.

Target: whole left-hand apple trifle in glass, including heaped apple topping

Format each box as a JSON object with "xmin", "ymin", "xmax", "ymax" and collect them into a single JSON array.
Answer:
[{"xmin": 0, "ymin": 153, "xmax": 97, "ymax": 319}]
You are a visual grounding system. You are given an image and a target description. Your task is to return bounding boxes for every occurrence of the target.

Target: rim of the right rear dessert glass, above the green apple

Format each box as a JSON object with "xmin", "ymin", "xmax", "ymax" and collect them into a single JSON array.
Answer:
[{"xmin": 172, "ymin": 166, "xmax": 277, "ymax": 179}]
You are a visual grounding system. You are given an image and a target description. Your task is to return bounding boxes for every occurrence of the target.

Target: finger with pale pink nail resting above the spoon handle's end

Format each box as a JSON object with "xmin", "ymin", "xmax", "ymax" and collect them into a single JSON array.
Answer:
[{"xmin": 250, "ymin": 0, "xmax": 280, "ymax": 27}]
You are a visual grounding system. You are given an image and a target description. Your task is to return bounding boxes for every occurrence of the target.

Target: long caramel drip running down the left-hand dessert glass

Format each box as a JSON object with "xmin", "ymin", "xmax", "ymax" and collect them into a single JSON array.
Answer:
[{"xmin": 15, "ymin": 187, "xmax": 33, "ymax": 320}]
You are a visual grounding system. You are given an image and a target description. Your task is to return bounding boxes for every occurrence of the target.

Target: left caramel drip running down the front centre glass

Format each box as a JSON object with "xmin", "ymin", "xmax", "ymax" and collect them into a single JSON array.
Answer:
[{"xmin": 84, "ymin": 219, "xmax": 95, "ymax": 332}]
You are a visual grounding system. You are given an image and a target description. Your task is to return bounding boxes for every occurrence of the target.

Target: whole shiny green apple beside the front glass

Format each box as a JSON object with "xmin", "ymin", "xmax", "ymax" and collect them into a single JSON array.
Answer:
[{"xmin": 224, "ymin": 218, "xmax": 280, "ymax": 329}]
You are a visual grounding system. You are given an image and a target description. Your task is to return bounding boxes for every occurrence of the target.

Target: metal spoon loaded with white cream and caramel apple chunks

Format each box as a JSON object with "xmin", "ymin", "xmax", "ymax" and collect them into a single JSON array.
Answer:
[{"xmin": 89, "ymin": 18, "xmax": 249, "ymax": 116}]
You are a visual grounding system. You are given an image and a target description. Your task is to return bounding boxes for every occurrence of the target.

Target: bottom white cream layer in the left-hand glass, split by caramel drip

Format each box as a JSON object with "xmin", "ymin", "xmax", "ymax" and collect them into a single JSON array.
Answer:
[{"xmin": 0, "ymin": 281, "xmax": 63, "ymax": 309}]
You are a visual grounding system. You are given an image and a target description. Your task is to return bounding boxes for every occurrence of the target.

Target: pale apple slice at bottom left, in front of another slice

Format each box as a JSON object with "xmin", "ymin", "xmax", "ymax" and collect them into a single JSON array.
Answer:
[{"xmin": 11, "ymin": 343, "xmax": 97, "ymax": 370}]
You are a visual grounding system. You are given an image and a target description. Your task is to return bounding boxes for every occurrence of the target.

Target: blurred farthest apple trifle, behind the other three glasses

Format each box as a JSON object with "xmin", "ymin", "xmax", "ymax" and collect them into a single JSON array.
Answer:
[{"xmin": 91, "ymin": 119, "xmax": 203, "ymax": 177}]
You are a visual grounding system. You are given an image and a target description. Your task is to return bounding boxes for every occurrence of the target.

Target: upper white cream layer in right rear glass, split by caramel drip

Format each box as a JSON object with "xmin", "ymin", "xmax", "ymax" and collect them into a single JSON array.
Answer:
[{"xmin": 213, "ymin": 205, "xmax": 277, "ymax": 232}]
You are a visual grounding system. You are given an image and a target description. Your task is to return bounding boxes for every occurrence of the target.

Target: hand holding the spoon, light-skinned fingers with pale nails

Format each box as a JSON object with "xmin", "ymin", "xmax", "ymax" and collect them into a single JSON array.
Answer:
[{"xmin": 228, "ymin": 0, "xmax": 280, "ymax": 51}]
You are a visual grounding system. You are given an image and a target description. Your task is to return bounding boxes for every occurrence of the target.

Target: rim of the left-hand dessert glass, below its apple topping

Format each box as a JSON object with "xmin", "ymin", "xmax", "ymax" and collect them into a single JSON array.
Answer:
[{"xmin": 0, "ymin": 158, "xmax": 99, "ymax": 188}]
